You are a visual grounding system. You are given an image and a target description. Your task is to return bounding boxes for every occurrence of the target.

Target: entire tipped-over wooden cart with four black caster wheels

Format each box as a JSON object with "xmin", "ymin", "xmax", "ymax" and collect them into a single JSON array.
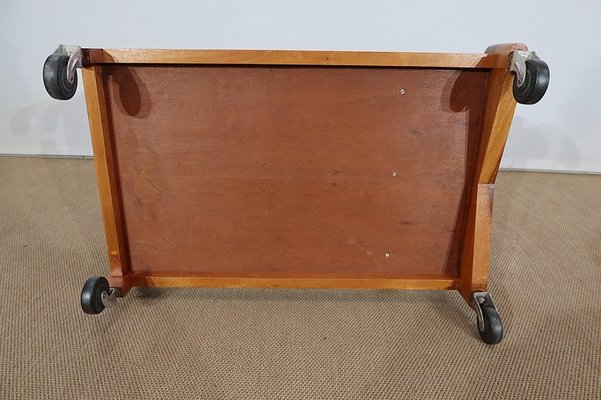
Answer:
[{"xmin": 43, "ymin": 44, "xmax": 549, "ymax": 344}]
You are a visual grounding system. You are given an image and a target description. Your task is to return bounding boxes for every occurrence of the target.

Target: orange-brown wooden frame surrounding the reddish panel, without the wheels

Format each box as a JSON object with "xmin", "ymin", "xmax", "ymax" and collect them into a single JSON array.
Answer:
[{"xmin": 82, "ymin": 43, "xmax": 527, "ymax": 302}]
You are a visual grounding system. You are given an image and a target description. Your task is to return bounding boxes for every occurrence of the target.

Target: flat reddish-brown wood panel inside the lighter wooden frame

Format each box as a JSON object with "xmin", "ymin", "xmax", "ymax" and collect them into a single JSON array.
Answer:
[{"xmin": 103, "ymin": 65, "xmax": 489, "ymax": 278}]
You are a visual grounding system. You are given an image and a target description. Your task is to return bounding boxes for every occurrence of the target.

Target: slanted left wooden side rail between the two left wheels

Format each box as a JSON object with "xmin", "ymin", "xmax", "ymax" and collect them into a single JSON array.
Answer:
[{"xmin": 82, "ymin": 67, "xmax": 129, "ymax": 277}]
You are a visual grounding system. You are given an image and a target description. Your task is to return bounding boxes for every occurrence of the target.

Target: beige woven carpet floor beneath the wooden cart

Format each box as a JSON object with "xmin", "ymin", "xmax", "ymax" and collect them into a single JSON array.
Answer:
[{"xmin": 0, "ymin": 157, "xmax": 601, "ymax": 400}]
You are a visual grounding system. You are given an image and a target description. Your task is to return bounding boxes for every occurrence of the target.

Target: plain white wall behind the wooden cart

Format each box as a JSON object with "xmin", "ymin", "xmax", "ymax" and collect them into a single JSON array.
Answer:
[{"xmin": 0, "ymin": 0, "xmax": 601, "ymax": 172}]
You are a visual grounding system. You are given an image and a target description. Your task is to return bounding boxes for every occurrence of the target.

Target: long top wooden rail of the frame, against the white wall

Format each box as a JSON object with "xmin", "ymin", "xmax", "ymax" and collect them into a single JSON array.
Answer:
[{"xmin": 83, "ymin": 49, "xmax": 503, "ymax": 69}]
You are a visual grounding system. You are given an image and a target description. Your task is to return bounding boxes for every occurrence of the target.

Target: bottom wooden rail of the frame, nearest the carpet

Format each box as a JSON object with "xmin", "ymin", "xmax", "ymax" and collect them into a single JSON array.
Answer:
[{"xmin": 123, "ymin": 273, "xmax": 459, "ymax": 290}]
